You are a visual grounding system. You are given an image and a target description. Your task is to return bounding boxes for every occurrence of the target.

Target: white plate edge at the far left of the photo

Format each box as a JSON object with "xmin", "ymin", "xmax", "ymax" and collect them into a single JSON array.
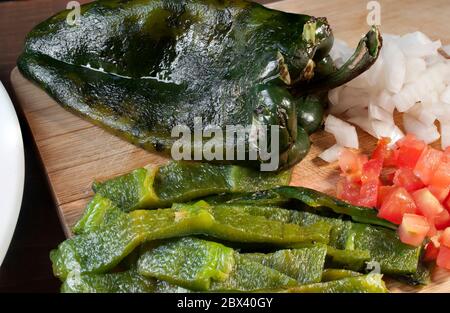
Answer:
[{"xmin": 0, "ymin": 82, "xmax": 25, "ymax": 265}]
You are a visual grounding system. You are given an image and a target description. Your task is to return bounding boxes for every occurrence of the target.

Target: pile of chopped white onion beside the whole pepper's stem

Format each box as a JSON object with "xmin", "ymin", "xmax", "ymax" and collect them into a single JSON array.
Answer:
[{"xmin": 320, "ymin": 32, "xmax": 450, "ymax": 162}]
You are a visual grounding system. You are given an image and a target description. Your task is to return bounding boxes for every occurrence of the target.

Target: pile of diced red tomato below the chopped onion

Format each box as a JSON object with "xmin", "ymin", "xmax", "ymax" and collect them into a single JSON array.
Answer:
[{"xmin": 337, "ymin": 135, "xmax": 450, "ymax": 269}]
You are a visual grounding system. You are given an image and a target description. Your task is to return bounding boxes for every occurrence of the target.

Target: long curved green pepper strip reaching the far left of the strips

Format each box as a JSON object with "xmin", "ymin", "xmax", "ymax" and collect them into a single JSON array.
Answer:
[{"xmin": 50, "ymin": 201, "xmax": 330, "ymax": 279}]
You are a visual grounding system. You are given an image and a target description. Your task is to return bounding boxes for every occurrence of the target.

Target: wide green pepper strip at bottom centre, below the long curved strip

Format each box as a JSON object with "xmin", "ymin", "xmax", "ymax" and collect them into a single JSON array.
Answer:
[{"xmin": 138, "ymin": 238, "xmax": 302, "ymax": 291}]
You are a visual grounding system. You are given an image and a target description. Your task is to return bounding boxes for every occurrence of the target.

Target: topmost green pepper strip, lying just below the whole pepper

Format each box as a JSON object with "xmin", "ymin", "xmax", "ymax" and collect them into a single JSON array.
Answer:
[{"xmin": 93, "ymin": 162, "xmax": 291, "ymax": 211}]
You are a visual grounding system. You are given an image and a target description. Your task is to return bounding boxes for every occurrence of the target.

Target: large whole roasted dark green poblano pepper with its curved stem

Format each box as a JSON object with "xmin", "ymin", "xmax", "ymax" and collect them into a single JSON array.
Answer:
[{"xmin": 18, "ymin": 0, "xmax": 381, "ymax": 169}]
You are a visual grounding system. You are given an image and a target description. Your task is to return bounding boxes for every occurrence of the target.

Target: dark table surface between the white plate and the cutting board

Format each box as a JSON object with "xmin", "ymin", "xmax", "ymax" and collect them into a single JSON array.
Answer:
[{"xmin": 0, "ymin": 0, "xmax": 275, "ymax": 292}]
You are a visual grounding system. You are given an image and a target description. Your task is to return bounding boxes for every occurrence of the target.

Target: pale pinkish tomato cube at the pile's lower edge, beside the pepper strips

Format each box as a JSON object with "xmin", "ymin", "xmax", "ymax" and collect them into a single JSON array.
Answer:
[{"xmin": 398, "ymin": 213, "xmax": 430, "ymax": 247}]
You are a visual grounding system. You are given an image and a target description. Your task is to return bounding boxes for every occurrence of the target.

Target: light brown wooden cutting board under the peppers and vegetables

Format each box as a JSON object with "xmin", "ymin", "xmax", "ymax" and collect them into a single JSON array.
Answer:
[{"xmin": 11, "ymin": 0, "xmax": 450, "ymax": 292}]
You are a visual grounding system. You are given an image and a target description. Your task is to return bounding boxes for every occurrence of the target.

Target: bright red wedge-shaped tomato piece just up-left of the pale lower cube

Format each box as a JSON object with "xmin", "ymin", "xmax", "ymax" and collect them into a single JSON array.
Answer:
[{"xmin": 378, "ymin": 187, "xmax": 417, "ymax": 224}]
